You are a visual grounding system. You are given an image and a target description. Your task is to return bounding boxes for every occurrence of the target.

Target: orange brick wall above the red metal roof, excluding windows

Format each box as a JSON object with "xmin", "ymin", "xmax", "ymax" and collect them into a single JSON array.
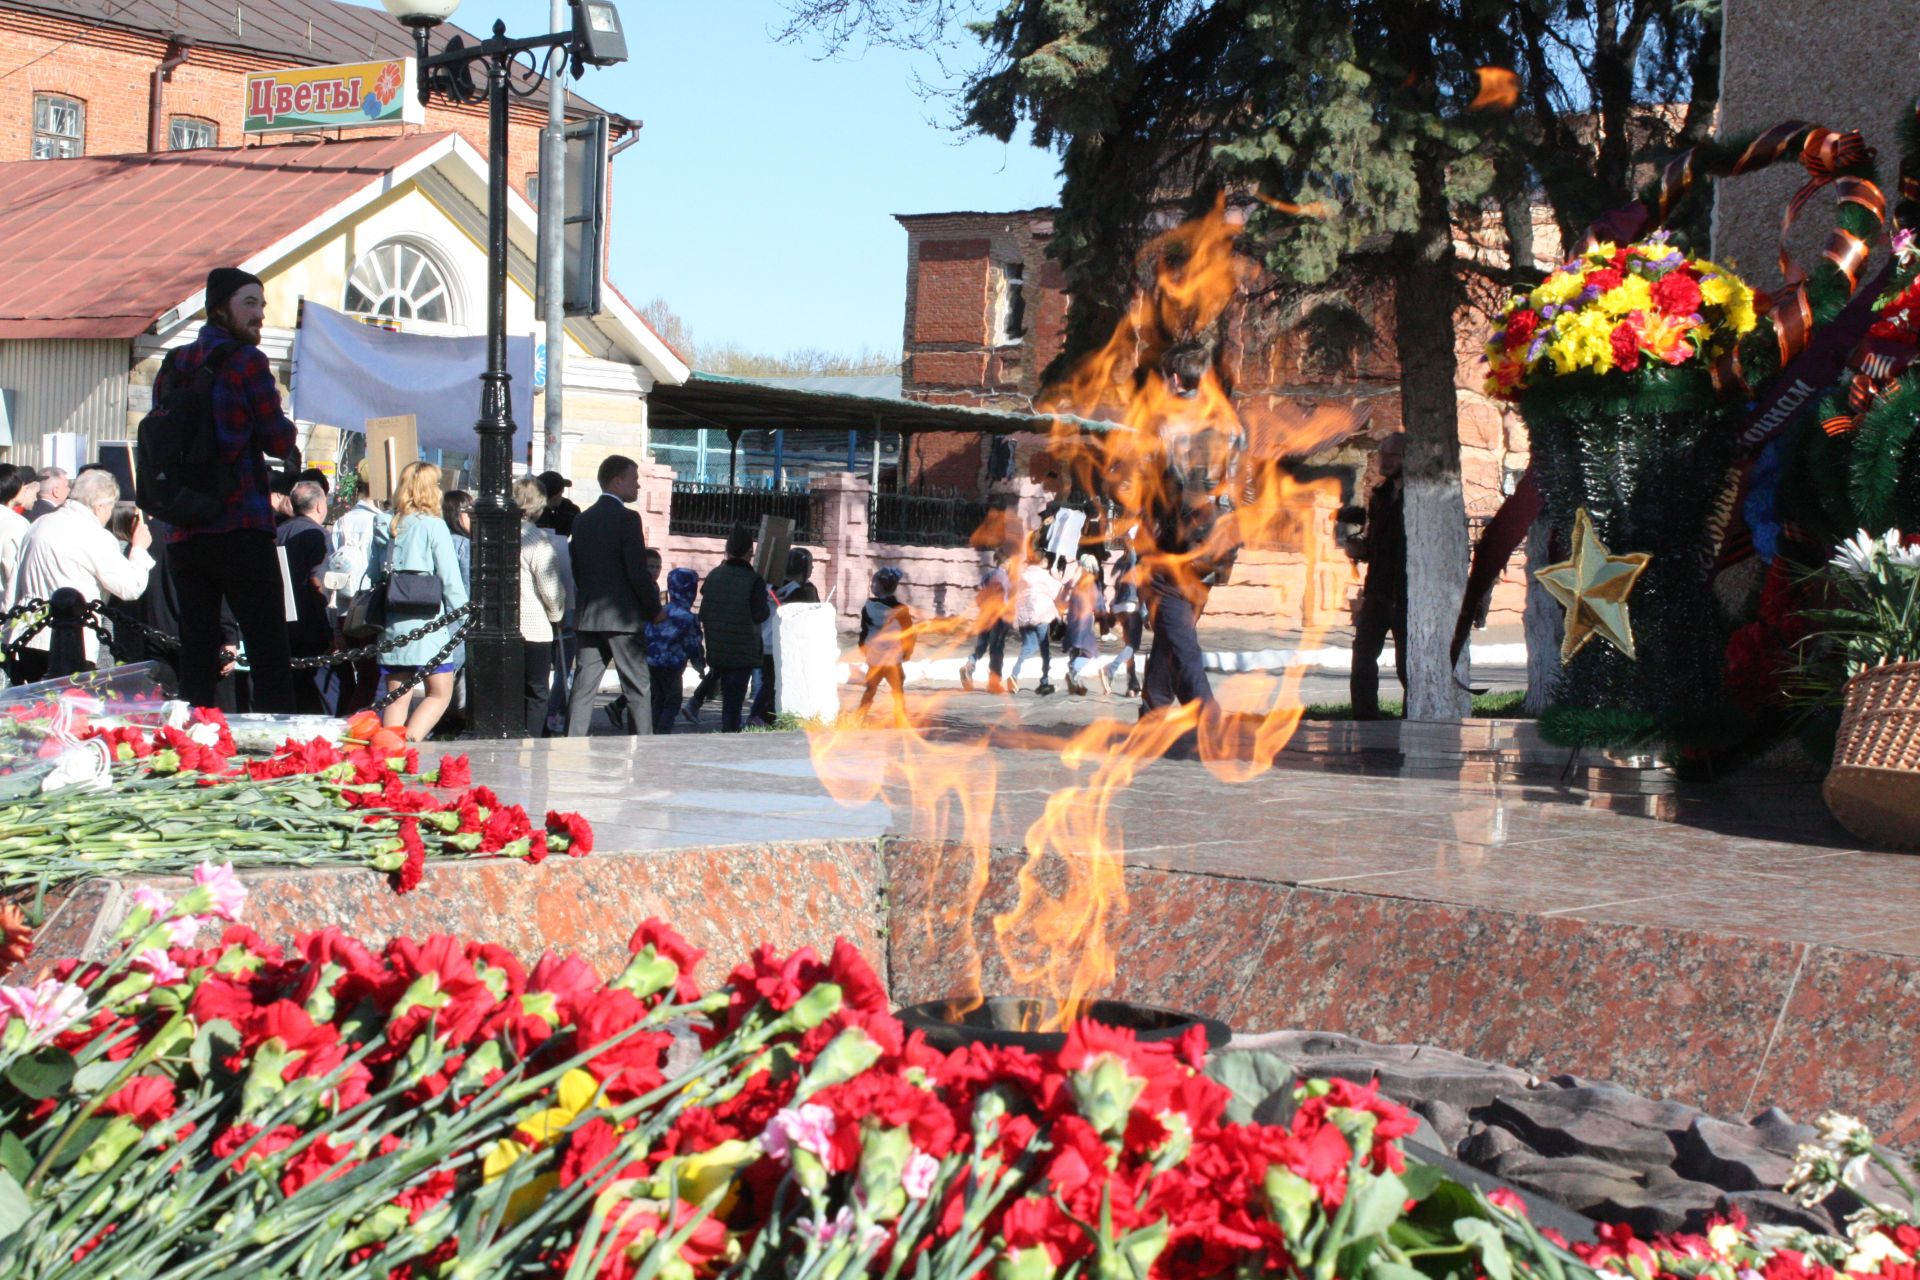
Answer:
[{"xmin": 0, "ymin": 10, "xmax": 564, "ymax": 194}]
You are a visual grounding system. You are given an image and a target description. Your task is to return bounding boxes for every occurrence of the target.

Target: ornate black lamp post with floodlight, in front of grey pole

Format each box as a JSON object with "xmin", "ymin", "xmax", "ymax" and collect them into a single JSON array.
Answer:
[{"xmin": 380, "ymin": 0, "xmax": 626, "ymax": 739}]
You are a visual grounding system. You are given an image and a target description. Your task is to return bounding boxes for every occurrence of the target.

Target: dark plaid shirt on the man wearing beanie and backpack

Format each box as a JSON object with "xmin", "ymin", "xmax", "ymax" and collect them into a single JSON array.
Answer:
[{"xmin": 154, "ymin": 324, "xmax": 296, "ymax": 543}]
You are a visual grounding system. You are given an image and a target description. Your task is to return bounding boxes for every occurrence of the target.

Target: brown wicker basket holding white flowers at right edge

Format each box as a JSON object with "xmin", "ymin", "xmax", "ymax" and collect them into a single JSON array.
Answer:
[{"xmin": 1824, "ymin": 662, "xmax": 1920, "ymax": 848}]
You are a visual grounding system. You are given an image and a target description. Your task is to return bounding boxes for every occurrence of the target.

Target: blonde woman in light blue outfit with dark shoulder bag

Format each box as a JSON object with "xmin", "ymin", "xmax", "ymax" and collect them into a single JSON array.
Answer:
[{"xmin": 380, "ymin": 462, "xmax": 467, "ymax": 743}]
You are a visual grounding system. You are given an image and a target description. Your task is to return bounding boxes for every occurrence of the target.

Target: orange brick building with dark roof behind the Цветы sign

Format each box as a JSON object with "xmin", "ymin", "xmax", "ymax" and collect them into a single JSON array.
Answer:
[{"xmin": 0, "ymin": 0, "xmax": 637, "ymax": 200}]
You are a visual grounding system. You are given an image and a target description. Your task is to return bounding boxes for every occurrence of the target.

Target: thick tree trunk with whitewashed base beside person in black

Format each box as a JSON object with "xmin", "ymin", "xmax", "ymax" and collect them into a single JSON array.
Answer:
[{"xmin": 1394, "ymin": 154, "xmax": 1473, "ymax": 720}]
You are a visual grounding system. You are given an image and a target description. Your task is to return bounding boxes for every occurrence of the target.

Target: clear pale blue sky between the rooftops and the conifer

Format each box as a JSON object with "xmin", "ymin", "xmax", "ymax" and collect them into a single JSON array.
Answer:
[{"xmin": 363, "ymin": 0, "xmax": 1060, "ymax": 353}]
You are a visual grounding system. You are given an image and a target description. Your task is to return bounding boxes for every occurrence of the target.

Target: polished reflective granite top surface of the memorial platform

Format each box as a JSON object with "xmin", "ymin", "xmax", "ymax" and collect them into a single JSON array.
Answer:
[{"xmin": 445, "ymin": 722, "xmax": 1920, "ymax": 954}]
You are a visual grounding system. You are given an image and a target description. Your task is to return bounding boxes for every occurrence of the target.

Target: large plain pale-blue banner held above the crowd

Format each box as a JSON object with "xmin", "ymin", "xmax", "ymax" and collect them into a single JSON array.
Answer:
[{"xmin": 294, "ymin": 301, "xmax": 534, "ymax": 459}]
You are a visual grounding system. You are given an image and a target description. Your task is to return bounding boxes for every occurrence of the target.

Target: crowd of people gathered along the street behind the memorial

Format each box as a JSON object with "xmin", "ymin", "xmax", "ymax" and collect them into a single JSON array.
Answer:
[{"xmin": 0, "ymin": 267, "xmax": 1405, "ymax": 741}]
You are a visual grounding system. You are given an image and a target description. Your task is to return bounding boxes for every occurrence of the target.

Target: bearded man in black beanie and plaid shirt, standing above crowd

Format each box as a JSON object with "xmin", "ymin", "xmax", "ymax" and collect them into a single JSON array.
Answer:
[{"xmin": 154, "ymin": 267, "xmax": 298, "ymax": 712}]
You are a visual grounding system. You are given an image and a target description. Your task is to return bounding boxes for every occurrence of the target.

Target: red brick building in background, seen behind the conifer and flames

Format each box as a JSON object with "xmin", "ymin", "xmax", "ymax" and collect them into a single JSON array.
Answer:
[{"xmin": 883, "ymin": 209, "xmax": 1526, "ymax": 622}]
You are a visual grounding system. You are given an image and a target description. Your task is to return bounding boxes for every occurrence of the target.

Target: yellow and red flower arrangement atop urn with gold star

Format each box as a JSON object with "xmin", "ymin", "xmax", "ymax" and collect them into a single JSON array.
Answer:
[{"xmin": 1486, "ymin": 232, "xmax": 1759, "ymax": 399}]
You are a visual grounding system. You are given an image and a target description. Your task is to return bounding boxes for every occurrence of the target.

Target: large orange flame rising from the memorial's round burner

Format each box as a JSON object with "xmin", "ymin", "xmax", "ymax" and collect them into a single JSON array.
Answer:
[{"xmin": 812, "ymin": 201, "xmax": 1356, "ymax": 1029}]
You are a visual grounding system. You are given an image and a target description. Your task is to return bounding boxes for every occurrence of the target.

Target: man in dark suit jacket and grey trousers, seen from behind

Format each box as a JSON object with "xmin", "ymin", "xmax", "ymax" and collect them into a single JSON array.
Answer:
[{"xmin": 566, "ymin": 453, "xmax": 664, "ymax": 737}]
